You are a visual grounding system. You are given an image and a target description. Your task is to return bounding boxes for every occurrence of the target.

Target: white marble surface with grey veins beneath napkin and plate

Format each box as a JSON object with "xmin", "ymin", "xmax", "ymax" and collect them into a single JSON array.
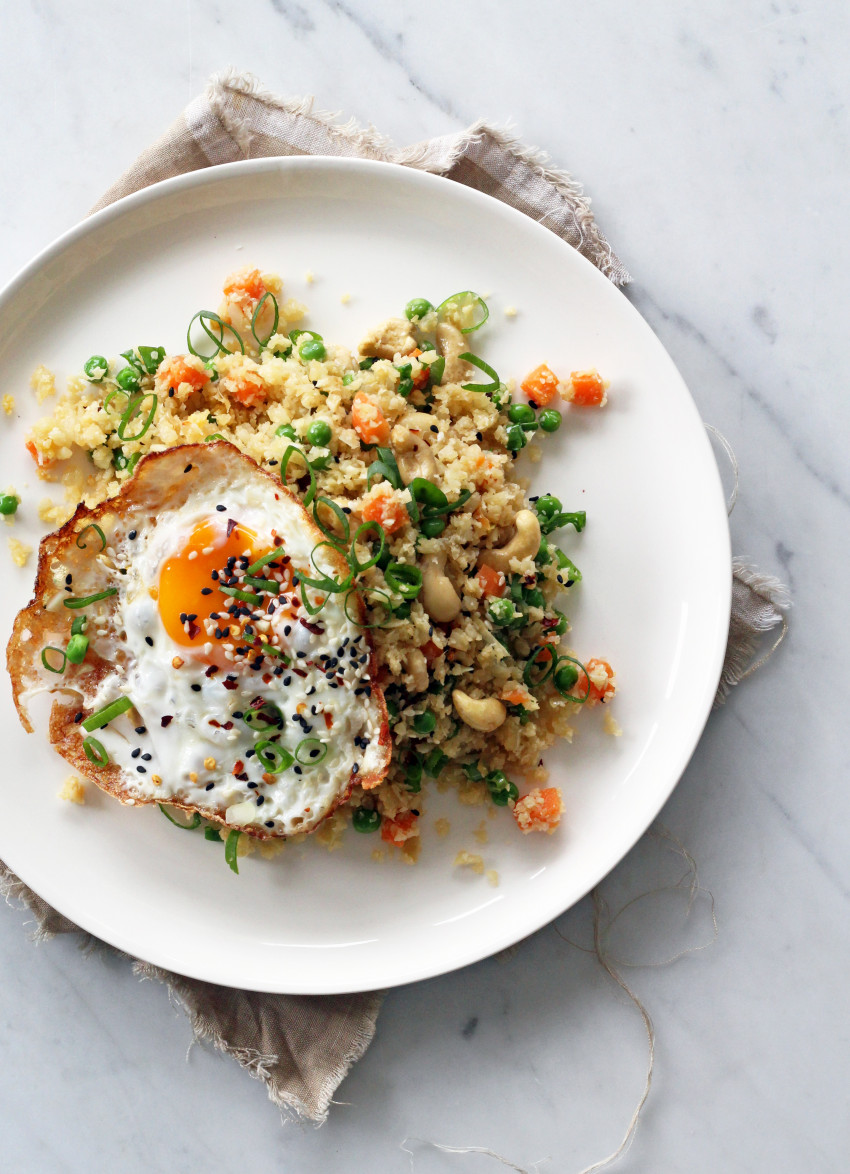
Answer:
[{"xmin": 0, "ymin": 0, "xmax": 850, "ymax": 1174}]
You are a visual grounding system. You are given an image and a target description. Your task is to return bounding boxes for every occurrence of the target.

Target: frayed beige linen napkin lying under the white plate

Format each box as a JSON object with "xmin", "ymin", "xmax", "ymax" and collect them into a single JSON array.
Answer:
[{"xmin": 0, "ymin": 73, "xmax": 788, "ymax": 1122}]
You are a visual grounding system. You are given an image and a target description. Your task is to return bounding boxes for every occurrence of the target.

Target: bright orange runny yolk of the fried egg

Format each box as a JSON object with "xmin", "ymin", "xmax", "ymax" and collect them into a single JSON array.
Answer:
[{"xmin": 158, "ymin": 519, "xmax": 269, "ymax": 660}]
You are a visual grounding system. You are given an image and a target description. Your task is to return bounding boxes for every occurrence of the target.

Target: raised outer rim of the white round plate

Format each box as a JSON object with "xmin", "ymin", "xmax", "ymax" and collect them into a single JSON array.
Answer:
[{"xmin": 0, "ymin": 155, "xmax": 733, "ymax": 994}]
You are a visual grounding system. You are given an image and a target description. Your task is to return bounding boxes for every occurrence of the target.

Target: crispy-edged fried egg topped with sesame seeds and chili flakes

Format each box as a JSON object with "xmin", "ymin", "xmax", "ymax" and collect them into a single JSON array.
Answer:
[{"xmin": 8, "ymin": 441, "xmax": 390, "ymax": 837}]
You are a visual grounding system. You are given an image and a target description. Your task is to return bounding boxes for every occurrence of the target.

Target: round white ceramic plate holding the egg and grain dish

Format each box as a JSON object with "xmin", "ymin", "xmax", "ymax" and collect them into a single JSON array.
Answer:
[{"xmin": 0, "ymin": 158, "xmax": 730, "ymax": 994}]
